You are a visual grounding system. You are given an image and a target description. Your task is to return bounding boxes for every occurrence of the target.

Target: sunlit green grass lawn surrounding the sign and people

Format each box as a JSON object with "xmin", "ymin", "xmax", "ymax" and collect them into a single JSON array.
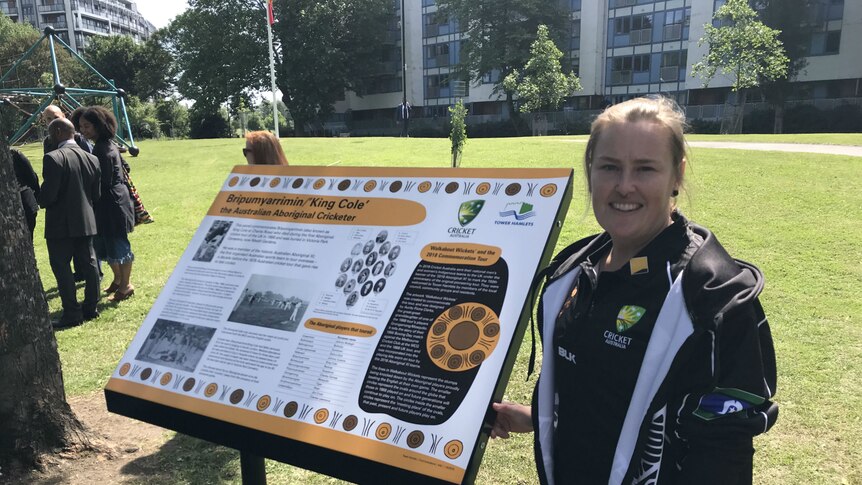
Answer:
[{"xmin": 15, "ymin": 134, "xmax": 862, "ymax": 484}]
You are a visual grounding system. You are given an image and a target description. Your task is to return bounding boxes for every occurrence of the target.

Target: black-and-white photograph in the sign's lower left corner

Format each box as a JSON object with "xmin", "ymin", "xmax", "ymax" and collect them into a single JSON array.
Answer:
[{"xmin": 135, "ymin": 318, "xmax": 216, "ymax": 372}]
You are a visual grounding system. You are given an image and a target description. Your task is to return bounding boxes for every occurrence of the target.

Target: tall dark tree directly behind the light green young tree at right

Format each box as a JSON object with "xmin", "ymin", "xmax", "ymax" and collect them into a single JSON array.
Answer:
[{"xmin": 754, "ymin": 0, "xmax": 812, "ymax": 133}]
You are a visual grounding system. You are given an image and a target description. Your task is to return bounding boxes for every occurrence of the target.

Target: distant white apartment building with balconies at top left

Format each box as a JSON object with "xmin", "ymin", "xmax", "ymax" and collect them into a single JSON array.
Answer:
[{"xmin": 0, "ymin": 0, "xmax": 156, "ymax": 51}]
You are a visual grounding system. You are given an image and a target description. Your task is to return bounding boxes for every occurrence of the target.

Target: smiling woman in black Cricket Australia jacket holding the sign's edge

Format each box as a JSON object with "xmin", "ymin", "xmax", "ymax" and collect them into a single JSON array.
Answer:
[{"xmin": 491, "ymin": 98, "xmax": 778, "ymax": 484}]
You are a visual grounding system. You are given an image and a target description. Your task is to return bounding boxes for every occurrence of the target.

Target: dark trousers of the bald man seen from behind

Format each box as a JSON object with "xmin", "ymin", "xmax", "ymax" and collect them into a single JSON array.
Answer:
[{"xmin": 45, "ymin": 236, "xmax": 99, "ymax": 323}]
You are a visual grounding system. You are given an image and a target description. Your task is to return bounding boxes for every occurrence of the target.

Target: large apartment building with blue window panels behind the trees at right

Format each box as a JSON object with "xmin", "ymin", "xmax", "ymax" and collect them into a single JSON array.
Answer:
[{"xmin": 336, "ymin": 0, "xmax": 862, "ymax": 127}]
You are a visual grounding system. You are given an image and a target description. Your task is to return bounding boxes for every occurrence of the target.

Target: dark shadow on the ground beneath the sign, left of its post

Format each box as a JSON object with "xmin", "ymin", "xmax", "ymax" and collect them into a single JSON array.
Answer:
[{"xmin": 121, "ymin": 433, "xmax": 240, "ymax": 484}]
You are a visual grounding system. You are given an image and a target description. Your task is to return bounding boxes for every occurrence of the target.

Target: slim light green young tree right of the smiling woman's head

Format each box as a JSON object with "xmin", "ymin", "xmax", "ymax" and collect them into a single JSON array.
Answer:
[{"xmin": 692, "ymin": 0, "xmax": 788, "ymax": 133}]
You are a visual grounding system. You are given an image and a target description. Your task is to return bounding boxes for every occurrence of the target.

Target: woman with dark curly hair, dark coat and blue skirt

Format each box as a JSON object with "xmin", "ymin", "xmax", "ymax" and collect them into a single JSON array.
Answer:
[{"xmin": 79, "ymin": 106, "xmax": 135, "ymax": 302}]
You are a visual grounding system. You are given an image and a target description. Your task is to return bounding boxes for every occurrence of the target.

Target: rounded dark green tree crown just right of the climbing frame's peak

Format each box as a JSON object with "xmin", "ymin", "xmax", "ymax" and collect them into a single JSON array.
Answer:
[{"xmin": 84, "ymin": 32, "xmax": 176, "ymax": 99}]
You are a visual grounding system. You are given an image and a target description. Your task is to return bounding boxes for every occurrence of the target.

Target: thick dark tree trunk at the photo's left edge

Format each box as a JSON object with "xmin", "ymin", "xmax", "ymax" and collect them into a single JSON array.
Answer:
[{"xmin": 0, "ymin": 138, "xmax": 90, "ymax": 472}]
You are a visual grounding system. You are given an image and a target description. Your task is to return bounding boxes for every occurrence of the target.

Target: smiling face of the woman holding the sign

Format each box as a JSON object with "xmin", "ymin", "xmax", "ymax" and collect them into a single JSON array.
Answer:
[{"xmin": 589, "ymin": 121, "xmax": 685, "ymax": 256}]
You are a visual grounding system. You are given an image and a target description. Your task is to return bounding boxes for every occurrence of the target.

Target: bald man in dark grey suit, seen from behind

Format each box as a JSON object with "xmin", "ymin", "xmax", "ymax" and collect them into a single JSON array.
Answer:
[{"xmin": 39, "ymin": 118, "xmax": 101, "ymax": 328}]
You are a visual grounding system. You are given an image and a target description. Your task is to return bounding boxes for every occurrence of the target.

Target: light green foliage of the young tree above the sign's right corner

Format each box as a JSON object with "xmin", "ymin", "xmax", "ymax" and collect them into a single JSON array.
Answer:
[{"xmin": 503, "ymin": 25, "xmax": 581, "ymax": 112}]
